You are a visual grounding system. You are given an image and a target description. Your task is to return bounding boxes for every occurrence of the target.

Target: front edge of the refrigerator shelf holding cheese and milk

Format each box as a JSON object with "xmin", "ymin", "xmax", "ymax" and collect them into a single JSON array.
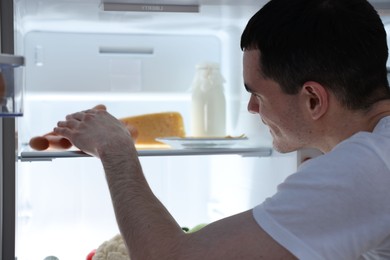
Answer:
[{"xmin": 19, "ymin": 147, "xmax": 272, "ymax": 162}]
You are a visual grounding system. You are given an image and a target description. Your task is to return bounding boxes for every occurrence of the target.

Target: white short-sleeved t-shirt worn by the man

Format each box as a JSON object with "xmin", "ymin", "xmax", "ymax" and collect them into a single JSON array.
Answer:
[{"xmin": 253, "ymin": 116, "xmax": 390, "ymax": 260}]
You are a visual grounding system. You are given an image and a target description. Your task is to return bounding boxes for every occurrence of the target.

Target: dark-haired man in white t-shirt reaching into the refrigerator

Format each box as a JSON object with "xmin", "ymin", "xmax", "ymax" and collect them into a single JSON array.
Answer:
[{"xmin": 55, "ymin": 0, "xmax": 390, "ymax": 260}]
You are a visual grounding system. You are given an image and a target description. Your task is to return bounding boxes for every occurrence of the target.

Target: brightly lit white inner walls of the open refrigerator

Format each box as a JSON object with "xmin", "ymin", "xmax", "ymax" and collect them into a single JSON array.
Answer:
[{"xmin": 10, "ymin": 0, "xmax": 390, "ymax": 260}]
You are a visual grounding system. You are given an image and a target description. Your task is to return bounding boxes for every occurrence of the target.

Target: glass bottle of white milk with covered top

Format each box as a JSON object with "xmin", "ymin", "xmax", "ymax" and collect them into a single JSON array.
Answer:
[{"xmin": 191, "ymin": 63, "xmax": 226, "ymax": 137}]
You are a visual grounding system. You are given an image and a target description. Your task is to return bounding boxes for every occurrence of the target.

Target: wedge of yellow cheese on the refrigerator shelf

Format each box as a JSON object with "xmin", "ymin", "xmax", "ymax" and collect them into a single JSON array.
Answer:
[{"xmin": 120, "ymin": 112, "xmax": 185, "ymax": 148}]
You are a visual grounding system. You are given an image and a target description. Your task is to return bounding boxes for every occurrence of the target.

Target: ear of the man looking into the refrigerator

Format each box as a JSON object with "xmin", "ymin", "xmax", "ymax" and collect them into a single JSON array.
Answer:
[{"xmin": 301, "ymin": 81, "xmax": 329, "ymax": 120}]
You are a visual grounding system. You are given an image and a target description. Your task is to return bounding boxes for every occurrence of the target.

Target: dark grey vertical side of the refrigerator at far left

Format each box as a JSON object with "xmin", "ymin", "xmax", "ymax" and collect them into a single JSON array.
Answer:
[{"xmin": 0, "ymin": 0, "xmax": 16, "ymax": 260}]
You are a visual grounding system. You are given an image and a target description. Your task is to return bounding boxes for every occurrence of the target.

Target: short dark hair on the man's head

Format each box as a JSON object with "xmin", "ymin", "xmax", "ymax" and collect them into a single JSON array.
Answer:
[{"xmin": 241, "ymin": 0, "xmax": 390, "ymax": 109}]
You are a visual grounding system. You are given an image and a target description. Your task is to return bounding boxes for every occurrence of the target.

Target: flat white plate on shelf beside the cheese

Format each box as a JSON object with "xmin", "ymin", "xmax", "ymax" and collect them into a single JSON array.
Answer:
[{"xmin": 156, "ymin": 137, "xmax": 248, "ymax": 149}]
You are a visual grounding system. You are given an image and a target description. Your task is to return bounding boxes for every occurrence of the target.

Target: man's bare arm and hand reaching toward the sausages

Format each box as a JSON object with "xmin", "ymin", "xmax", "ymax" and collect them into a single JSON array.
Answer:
[{"xmin": 55, "ymin": 106, "xmax": 295, "ymax": 260}]
